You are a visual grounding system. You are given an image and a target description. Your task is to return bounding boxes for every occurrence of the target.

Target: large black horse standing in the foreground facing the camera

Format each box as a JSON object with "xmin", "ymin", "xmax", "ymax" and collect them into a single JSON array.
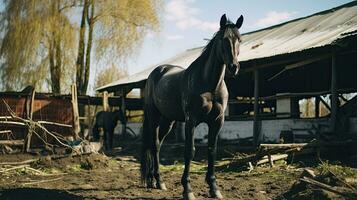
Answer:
[{"xmin": 141, "ymin": 15, "xmax": 243, "ymax": 200}]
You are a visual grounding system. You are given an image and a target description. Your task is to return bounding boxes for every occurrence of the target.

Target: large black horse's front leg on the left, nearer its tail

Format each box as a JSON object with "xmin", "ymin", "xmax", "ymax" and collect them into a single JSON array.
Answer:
[{"xmin": 181, "ymin": 120, "xmax": 195, "ymax": 200}]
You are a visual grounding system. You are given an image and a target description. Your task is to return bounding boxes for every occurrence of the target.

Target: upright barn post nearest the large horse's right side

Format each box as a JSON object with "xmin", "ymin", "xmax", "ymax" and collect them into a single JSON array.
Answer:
[{"xmin": 253, "ymin": 69, "xmax": 260, "ymax": 146}]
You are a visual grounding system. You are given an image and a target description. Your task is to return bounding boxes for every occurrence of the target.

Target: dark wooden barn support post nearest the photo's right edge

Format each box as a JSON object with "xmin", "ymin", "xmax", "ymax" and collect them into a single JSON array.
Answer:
[{"xmin": 330, "ymin": 52, "xmax": 338, "ymax": 132}]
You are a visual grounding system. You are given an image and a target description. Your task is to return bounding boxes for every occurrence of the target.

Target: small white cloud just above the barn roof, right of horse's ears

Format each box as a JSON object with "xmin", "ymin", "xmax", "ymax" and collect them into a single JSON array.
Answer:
[{"xmin": 255, "ymin": 11, "xmax": 297, "ymax": 27}]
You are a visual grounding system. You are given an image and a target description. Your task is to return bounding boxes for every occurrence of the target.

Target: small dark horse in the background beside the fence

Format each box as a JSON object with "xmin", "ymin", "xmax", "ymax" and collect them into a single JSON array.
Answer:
[{"xmin": 92, "ymin": 110, "xmax": 125, "ymax": 150}]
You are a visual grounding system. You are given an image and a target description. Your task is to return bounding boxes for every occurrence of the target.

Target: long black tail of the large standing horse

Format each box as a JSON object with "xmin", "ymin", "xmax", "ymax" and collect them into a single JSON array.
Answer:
[{"xmin": 140, "ymin": 106, "xmax": 154, "ymax": 184}]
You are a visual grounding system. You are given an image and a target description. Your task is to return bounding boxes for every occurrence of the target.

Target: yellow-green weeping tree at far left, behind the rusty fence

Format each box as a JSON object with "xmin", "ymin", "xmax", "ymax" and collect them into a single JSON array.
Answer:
[{"xmin": 0, "ymin": 0, "xmax": 77, "ymax": 93}]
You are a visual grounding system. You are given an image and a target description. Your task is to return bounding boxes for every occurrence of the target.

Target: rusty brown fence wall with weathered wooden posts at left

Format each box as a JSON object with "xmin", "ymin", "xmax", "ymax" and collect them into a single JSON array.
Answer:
[{"xmin": 0, "ymin": 85, "xmax": 142, "ymax": 150}]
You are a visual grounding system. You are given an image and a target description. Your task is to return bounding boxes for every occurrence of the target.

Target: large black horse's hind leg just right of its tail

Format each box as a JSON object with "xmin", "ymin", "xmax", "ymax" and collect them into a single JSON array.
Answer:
[{"xmin": 153, "ymin": 117, "xmax": 173, "ymax": 190}]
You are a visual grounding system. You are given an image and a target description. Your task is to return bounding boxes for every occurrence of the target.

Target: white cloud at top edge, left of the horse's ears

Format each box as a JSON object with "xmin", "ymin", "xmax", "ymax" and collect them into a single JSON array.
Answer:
[{"xmin": 165, "ymin": 0, "xmax": 219, "ymax": 31}]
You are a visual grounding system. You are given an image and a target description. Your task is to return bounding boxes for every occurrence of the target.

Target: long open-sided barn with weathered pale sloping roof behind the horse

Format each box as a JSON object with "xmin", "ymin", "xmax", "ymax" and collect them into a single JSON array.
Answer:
[{"xmin": 97, "ymin": 1, "xmax": 357, "ymax": 143}]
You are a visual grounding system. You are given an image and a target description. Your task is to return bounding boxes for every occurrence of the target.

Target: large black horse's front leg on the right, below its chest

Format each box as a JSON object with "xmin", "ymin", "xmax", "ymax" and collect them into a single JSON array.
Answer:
[{"xmin": 206, "ymin": 116, "xmax": 224, "ymax": 199}]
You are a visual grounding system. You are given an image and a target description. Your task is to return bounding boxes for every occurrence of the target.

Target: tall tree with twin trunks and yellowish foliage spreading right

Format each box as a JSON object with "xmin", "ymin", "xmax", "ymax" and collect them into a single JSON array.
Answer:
[{"xmin": 76, "ymin": 0, "xmax": 161, "ymax": 94}]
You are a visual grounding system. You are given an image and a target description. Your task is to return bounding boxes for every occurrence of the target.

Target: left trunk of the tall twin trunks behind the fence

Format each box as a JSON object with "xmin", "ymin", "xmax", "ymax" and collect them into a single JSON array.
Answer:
[{"xmin": 76, "ymin": 0, "xmax": 89, "ymax": 95}]
